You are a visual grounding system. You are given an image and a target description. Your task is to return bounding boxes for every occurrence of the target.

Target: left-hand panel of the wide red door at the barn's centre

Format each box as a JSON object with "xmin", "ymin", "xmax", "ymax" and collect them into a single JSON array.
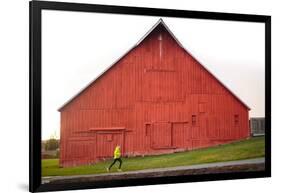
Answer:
[{"xmin": 151, "ymin": 123, "xmax": 172, "ymax": 149}]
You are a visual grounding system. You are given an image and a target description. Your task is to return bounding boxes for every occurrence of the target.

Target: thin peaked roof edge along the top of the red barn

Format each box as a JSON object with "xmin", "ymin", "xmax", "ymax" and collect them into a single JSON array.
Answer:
[{"xmin": 58, "ymin": 18, "xmax": 251, "ymax": 111}]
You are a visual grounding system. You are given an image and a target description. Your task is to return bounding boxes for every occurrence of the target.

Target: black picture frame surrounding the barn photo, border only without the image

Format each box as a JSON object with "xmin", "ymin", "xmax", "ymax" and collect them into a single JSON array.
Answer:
[{"xmin": 29, "ymin": 1, "xmax": 271, "ymax": 192}]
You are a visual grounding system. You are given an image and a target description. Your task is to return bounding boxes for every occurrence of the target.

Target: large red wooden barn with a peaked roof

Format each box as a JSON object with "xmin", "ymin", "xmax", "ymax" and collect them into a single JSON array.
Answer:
[{"xmin": 59, "ymin": 19, "xmax": 250, "ymax": 167}]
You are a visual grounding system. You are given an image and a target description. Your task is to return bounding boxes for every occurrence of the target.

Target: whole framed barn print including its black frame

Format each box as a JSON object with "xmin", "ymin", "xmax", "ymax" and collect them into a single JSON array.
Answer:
[{"xmin": 29, "ymin": 1, "xmax": 271, "ymax": 192}]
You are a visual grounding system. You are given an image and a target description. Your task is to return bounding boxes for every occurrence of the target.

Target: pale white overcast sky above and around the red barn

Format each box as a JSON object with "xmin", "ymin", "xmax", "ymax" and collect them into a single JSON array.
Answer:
[{"xmin": 42, "ymin": 10, "xmax": 265, "ymax": 139}]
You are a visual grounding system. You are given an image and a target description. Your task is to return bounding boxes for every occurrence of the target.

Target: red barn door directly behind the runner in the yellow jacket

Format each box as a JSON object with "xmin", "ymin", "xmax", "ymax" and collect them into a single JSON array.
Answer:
[{"xmin": 96, "ymin": 132, "xmax": 124, "ymax": 158}]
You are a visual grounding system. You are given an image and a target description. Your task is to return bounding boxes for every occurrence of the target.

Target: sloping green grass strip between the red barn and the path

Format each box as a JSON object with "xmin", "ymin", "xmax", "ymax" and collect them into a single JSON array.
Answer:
[{"xmin": 42, "ymin": 137, "xmax": 264, "ymax": 176}]
